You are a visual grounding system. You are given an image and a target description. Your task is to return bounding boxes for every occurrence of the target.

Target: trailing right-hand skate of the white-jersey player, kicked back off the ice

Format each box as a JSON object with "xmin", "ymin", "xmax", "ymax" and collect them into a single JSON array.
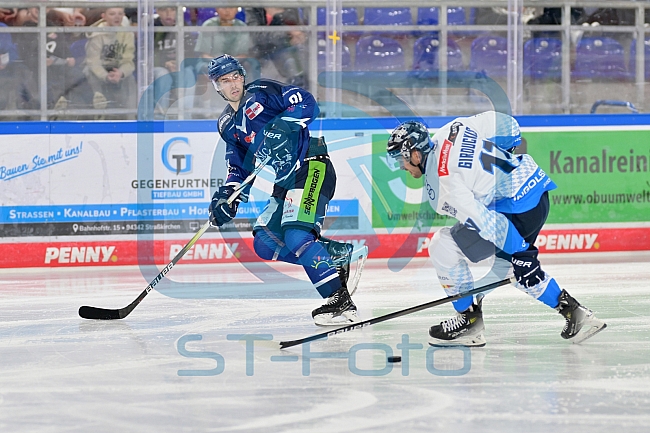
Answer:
[{"xmin": 556, "ymin": 290, "xmax": 607, "ymax": 344}]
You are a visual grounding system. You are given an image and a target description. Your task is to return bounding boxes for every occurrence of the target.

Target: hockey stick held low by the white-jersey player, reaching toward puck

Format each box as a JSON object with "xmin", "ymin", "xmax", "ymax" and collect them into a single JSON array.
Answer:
[{"xmin": 280, "ymin": 277, "xmax": 517, "ymax": 349}]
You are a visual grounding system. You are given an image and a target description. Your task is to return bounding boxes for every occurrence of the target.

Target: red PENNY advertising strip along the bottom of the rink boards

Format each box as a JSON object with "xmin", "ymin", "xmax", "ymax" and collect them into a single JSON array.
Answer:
[{"xmin": 0, "ymin": 224, "xmax": 650, "ymax": 268}]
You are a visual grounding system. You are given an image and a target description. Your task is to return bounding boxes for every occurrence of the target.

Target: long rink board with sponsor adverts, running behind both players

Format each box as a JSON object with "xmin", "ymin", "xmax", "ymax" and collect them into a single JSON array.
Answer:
[{"xmin": 0, "ymin": 115, "xmax": 650, "ymax": 268}]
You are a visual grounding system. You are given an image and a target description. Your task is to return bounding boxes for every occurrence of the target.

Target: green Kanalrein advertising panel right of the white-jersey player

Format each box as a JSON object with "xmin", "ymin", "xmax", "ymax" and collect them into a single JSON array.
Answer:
[{"xmin": 523, "ymin": 131, "xmax": 650, "ymax": 223}]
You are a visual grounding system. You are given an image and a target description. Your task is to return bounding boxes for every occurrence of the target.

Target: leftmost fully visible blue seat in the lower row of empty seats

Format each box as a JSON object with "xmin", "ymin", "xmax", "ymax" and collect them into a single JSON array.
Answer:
[{"xmin": 355, "ymin": 35, "xmax": 404, "ymax": 71}]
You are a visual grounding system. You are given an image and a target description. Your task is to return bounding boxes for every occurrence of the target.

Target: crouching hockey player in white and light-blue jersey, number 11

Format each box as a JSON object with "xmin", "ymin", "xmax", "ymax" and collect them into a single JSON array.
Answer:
[{"xmin": 387, "ymin": 111, "xmax": 606, "ymax": 347}]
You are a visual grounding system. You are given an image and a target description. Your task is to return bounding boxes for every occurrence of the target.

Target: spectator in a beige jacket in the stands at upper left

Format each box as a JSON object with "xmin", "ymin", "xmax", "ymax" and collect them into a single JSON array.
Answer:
[{"xmin": 84, "ymin": 8, "xmax": 136, "ymax": 118}]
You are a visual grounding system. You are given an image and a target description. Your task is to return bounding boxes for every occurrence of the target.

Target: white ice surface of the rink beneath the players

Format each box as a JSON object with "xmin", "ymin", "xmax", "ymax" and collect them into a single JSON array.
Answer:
[{"xmin": 0, "ymin": 253, "xmax": 650, "ymax": 433}]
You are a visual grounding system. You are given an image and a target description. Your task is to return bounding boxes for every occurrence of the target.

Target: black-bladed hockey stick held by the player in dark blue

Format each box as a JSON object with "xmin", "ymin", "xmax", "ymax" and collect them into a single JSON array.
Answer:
[{"xmin": 79, "ymin": 156, "xmax": 271, "ymax": 320}]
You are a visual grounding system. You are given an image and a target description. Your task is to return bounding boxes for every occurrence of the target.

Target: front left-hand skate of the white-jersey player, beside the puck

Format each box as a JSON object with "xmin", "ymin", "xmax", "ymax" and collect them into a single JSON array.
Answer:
[{"xmin": 429, "ymin": 296, "xmax": 485, "ymax": 347}]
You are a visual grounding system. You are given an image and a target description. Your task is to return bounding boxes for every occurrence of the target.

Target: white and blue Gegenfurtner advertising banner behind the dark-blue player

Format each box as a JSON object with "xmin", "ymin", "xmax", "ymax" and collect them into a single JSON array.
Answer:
[{"xmin": 0, "ymin": 133, "xmax": 359, "ymax": 240}]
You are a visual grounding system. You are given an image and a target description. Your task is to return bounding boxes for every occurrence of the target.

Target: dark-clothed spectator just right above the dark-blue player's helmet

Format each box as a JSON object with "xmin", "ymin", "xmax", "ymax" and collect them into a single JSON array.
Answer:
[{"xmin": 246, "ymin": 8, "xmax": 306, "ymax": 87}]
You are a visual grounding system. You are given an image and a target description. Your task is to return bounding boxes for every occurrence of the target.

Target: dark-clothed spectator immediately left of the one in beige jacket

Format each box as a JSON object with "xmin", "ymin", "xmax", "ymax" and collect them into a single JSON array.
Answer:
[{"xmin": 45, "ymin": 9, "xmax": 92, "ymax": 110}]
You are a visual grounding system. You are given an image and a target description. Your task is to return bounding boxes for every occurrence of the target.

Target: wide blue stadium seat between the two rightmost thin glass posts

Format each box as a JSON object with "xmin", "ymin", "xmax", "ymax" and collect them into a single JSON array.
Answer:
[{"xmin": 572, "ymin": 36, "xmax": 632, "ymax": 80}]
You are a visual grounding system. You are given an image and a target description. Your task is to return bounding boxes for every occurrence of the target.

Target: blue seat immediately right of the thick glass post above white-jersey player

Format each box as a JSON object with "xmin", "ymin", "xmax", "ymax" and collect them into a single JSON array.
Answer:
[{"xmin": 524, "ymin": 38, "xmax": 562, "ymax": 80}]
